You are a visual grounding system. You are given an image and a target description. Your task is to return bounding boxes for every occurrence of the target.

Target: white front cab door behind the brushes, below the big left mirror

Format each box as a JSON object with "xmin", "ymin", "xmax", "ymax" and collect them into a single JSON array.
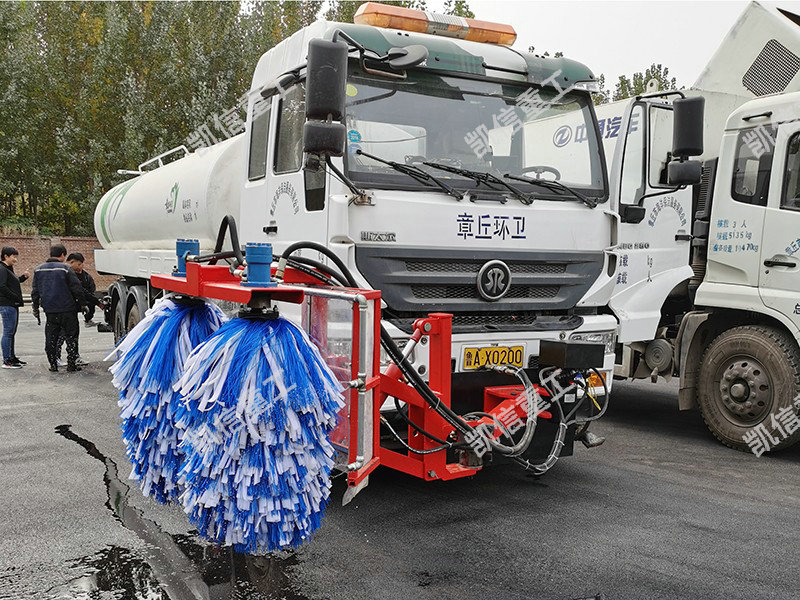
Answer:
[{"xmin": 264, "ymin": 82, "xmax": 328, "ymax": 258}]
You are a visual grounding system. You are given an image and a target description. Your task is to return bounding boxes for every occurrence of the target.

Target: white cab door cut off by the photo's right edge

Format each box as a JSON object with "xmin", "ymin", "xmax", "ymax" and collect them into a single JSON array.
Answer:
[{"xmin": 759, "ymin": 122, "xmax": 800, "ymax": 326}]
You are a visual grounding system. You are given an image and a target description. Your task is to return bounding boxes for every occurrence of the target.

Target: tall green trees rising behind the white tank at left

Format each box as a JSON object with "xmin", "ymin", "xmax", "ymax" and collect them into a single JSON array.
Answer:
[{"xmin": 0, "ymin": 0, "xmax": 471, "ymax": 234}]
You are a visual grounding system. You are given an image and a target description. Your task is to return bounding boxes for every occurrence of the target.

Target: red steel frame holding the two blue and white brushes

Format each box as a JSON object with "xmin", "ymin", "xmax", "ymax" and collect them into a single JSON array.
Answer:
[{"xmin": 150, "ymin": 262, "xmax": 550, "ymax": 486}]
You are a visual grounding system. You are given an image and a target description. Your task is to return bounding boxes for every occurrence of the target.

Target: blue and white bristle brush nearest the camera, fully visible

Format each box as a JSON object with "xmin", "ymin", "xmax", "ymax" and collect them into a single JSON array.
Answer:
[{"xmin": 176, "ymin": 318, "xmax": 344, "ymax": 554}]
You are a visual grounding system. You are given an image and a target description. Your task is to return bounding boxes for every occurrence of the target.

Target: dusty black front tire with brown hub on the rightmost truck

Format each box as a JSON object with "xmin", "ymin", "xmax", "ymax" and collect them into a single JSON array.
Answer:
[{"xmin": 697, "ymin": 325, "xmax": 800, "ymax": 451}]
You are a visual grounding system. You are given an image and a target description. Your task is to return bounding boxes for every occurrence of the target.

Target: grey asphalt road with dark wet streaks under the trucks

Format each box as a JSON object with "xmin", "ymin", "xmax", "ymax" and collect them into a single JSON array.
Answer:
[{"xmin": 0, "ymin": 312, "xmax": 800, "ymax": 600}]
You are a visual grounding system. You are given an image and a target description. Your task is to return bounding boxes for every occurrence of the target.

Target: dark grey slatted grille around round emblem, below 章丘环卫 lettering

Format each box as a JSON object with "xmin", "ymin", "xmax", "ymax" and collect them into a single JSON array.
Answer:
[{"xmin": 356, "ymin": 244, "xmax": 604, "ymax": 319}]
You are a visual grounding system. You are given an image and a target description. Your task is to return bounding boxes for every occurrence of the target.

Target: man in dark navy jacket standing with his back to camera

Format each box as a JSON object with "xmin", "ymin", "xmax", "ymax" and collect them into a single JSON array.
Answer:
[{"xmin": 31, "ymin": 245, "xmax": 86, "ymax": 373}]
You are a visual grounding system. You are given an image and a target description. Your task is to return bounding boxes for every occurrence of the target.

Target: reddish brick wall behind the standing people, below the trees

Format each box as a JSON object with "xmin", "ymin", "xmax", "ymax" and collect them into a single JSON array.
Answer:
[{"xmin": 0, "ymin": 236, "xmax": 115, "ymax": 295}]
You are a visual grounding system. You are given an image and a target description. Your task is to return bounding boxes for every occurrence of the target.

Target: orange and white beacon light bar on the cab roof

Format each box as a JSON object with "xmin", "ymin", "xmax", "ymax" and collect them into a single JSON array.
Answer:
[{"xmin": 353, "ymin": 2, "xmax": 517, "ymax": 46}]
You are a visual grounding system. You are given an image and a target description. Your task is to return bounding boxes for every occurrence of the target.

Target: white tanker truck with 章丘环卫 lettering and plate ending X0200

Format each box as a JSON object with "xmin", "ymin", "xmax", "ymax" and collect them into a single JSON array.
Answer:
[{"xmin": 95, "ymin": 3, "xmax": 619, "ymax": 418}]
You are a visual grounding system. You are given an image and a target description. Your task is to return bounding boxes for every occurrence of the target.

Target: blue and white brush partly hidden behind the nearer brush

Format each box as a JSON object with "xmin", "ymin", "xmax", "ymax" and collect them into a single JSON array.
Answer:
[{"xmin": 106, "ymin": 296, "xmax": 226, "ymax": 503}]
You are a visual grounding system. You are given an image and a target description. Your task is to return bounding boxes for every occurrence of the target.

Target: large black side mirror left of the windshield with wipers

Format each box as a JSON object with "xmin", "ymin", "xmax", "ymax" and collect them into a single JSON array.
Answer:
[{"xmin": 303, "ymin": 39, "xmax": 348, "ymax": 156}]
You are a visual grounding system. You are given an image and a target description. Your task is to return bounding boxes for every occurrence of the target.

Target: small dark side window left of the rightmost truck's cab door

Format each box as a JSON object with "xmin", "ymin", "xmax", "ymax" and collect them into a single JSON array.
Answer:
[{"xmin": 731, "ymin": 125, "xmax": 775, "ymax": 206}]
